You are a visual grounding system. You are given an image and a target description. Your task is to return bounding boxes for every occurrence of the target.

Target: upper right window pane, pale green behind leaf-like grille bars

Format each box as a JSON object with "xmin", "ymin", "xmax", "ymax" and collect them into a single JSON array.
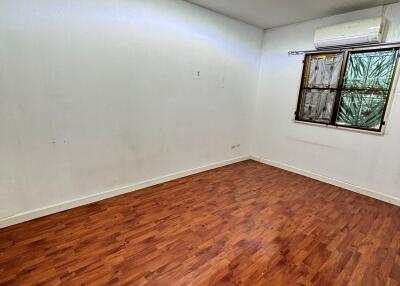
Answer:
[{"xmin": 343, "ymin": 50, "xmax": 398, "ymax": 90}]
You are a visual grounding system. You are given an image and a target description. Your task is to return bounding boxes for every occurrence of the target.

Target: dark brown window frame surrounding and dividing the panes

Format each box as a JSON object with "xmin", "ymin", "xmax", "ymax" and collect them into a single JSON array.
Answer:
[{"xmin": 294, "ymin": 44, "xmax": 400, "ymax": 134}]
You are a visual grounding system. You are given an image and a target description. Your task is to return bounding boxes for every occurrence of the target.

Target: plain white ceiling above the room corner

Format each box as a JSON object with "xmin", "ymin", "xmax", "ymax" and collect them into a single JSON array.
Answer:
[{"xmin": 187, "ymin": 0, "xmax": 400, "ymax": 29}]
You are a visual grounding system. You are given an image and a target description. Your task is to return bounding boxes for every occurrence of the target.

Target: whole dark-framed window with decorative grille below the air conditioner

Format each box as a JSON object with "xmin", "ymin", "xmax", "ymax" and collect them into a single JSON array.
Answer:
[{"xmin": 296, "ymin": 48, "xmax": 399, "ymax": 132}]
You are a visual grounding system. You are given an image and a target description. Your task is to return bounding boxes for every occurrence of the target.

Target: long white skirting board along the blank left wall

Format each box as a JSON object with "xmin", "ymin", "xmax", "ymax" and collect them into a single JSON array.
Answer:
[{"xmin": 0, "ymin": 156, "xmax": 250, "ymax": 228}]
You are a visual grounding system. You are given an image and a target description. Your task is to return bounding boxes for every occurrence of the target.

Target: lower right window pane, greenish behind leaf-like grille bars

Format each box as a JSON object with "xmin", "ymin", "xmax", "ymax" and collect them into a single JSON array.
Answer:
[{"xmin": 336, "ymin": 91, "xmax": 387, "ymax": 130}]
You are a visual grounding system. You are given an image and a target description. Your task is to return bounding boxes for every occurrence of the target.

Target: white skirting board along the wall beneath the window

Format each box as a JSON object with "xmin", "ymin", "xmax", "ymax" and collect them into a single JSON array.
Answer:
[{"xmin": 250, "ymin": 156, "xmax": 400, "ymax": 206}]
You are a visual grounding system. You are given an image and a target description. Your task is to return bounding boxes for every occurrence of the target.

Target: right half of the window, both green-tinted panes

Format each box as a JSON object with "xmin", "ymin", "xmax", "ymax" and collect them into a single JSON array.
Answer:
[{"xmin": 336, "ymin": 50, "xmax": 398, "ymax": 129}]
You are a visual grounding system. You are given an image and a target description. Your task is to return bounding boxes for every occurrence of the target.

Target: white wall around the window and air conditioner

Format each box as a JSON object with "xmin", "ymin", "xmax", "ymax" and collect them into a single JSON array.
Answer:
[{"xmin": 251, "ymin": 4, "xmax": 400, "ymax": 202}]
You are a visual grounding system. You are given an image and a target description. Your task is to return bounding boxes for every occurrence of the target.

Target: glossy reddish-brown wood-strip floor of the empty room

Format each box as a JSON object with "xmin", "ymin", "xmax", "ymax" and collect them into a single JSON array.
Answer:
[{"xmin": 0, "ymin": 161, "xmax": 400, "ymax": 286}]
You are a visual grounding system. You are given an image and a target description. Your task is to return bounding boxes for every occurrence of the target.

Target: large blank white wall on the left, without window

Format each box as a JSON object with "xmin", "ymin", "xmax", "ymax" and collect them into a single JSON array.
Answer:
[{"xmin": 0, "ymin": 0, "xmax": 263, "ymax": 219}]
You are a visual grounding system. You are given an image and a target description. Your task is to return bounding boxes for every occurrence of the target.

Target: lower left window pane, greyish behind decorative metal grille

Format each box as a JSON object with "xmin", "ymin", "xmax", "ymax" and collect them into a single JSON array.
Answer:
[{"xmin": 301, "ymin": 89, "xmax": 336, "ymax": 123}]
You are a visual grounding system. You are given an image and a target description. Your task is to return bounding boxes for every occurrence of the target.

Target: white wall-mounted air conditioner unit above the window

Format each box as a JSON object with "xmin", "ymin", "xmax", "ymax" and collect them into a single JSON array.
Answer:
[{"xmin": 314, "ymin": 17, "xmax": 385, "ymax": 49}]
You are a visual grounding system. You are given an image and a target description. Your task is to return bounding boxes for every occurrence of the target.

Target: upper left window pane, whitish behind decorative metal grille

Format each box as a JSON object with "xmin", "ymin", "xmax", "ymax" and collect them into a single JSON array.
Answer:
[{"xmin": 304, "ymin": 53, "xmax": 343, "ymax": 88}]
